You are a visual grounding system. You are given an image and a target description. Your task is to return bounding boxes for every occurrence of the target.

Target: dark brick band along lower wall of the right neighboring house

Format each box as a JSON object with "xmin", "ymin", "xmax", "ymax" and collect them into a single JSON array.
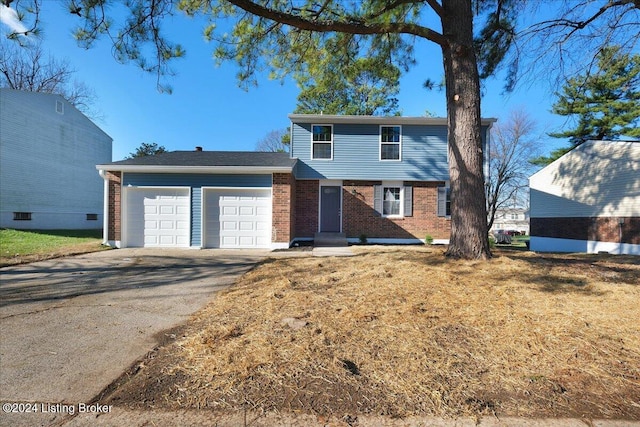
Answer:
[{"xmin": 531, "ymin": 217, "xmax": 640, "ymax": 245}]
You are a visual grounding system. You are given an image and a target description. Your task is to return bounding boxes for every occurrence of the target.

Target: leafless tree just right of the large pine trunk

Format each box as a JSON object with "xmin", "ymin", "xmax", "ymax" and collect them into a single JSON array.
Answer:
[{"xmin": 486, "ymin": 110, "xmax": 541, "ymax": 229}]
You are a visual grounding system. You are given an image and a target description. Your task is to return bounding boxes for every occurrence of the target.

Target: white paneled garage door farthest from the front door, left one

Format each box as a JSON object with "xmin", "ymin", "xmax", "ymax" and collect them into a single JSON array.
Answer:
[{"xmin": 124, "ymin": 188, "xmax": 190, "ymax": 247}]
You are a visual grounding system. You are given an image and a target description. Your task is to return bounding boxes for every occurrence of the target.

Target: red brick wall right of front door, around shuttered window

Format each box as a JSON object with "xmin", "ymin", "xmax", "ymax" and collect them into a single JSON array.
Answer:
[{"xmin": 342, "ymin": 181, "xmax": 451, "ymax": 239}]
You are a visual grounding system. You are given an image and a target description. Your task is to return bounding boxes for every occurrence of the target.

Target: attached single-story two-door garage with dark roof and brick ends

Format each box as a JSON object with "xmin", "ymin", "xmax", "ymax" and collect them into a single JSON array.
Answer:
[{"xmin": 96, "ymin": 149, "xmax": 297, "ymax": 249}]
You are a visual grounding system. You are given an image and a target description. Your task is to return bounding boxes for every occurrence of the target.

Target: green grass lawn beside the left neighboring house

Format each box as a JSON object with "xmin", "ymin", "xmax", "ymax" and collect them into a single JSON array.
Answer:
[{"xmin": 0, "ymin": 229, "xmax": 104, "ymax": 266}]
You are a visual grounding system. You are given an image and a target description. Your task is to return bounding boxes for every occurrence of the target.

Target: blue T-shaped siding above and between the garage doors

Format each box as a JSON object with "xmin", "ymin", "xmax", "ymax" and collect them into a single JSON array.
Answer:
[{"xmin": 122, "ymin": 172, "xmax": 273, "ymax": 246}]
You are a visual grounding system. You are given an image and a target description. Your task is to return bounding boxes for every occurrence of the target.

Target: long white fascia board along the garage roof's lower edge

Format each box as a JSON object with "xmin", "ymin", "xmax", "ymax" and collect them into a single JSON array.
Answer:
[{"xmin": 96, "ymin": 165, "xmax": 293, "ymax": 175}]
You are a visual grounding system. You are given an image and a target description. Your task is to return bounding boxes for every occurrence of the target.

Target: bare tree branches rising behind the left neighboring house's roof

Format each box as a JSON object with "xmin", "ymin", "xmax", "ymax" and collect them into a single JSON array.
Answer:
[{"xmin": 0, "ymin": 38, "xmax": 99, "ymax": 119}]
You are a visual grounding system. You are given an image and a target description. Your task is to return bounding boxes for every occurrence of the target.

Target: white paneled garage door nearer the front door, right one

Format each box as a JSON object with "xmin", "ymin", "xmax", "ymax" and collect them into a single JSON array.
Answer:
[{"xmin": 204, "ymin": 189, "xmax": 271, "ymax": 248}]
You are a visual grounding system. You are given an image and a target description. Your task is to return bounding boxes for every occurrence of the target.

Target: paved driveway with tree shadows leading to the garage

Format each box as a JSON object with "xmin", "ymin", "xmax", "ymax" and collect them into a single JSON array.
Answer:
[{"xmin": 0, "ymin": 249, "xmax": 268, "ymax": 426}]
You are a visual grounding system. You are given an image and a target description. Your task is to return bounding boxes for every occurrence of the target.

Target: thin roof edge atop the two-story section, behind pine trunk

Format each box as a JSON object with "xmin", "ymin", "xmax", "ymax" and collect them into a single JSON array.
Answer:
[{"xmin": 289, "ymin": 114, "xmax": 497, "ymax": 126}]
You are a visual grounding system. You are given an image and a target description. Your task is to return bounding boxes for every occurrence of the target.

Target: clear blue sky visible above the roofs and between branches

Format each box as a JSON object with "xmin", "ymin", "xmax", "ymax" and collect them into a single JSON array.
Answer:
[{"xmin": 1, "ymin": 0, "xmax": 565, "ymax": 161}]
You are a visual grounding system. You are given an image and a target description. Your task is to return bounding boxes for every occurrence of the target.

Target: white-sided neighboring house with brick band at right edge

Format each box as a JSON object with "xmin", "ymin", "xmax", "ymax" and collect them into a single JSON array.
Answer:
[{"xmin": 529, "ymin": 141, "xmax": 640, "ymax": 255}]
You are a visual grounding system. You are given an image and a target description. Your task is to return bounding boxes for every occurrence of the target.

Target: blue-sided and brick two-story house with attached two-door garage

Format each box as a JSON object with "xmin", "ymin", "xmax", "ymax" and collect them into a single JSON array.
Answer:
[{"xmin": 97, "ymin": 114, "xmax": 494, "ymax": 248}]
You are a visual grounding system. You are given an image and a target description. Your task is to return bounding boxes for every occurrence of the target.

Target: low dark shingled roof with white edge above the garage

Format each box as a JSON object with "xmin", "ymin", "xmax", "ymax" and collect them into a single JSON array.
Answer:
[{"xmin": 96, "ymin": 150, "xmax": 297, "ymax": 173}]
